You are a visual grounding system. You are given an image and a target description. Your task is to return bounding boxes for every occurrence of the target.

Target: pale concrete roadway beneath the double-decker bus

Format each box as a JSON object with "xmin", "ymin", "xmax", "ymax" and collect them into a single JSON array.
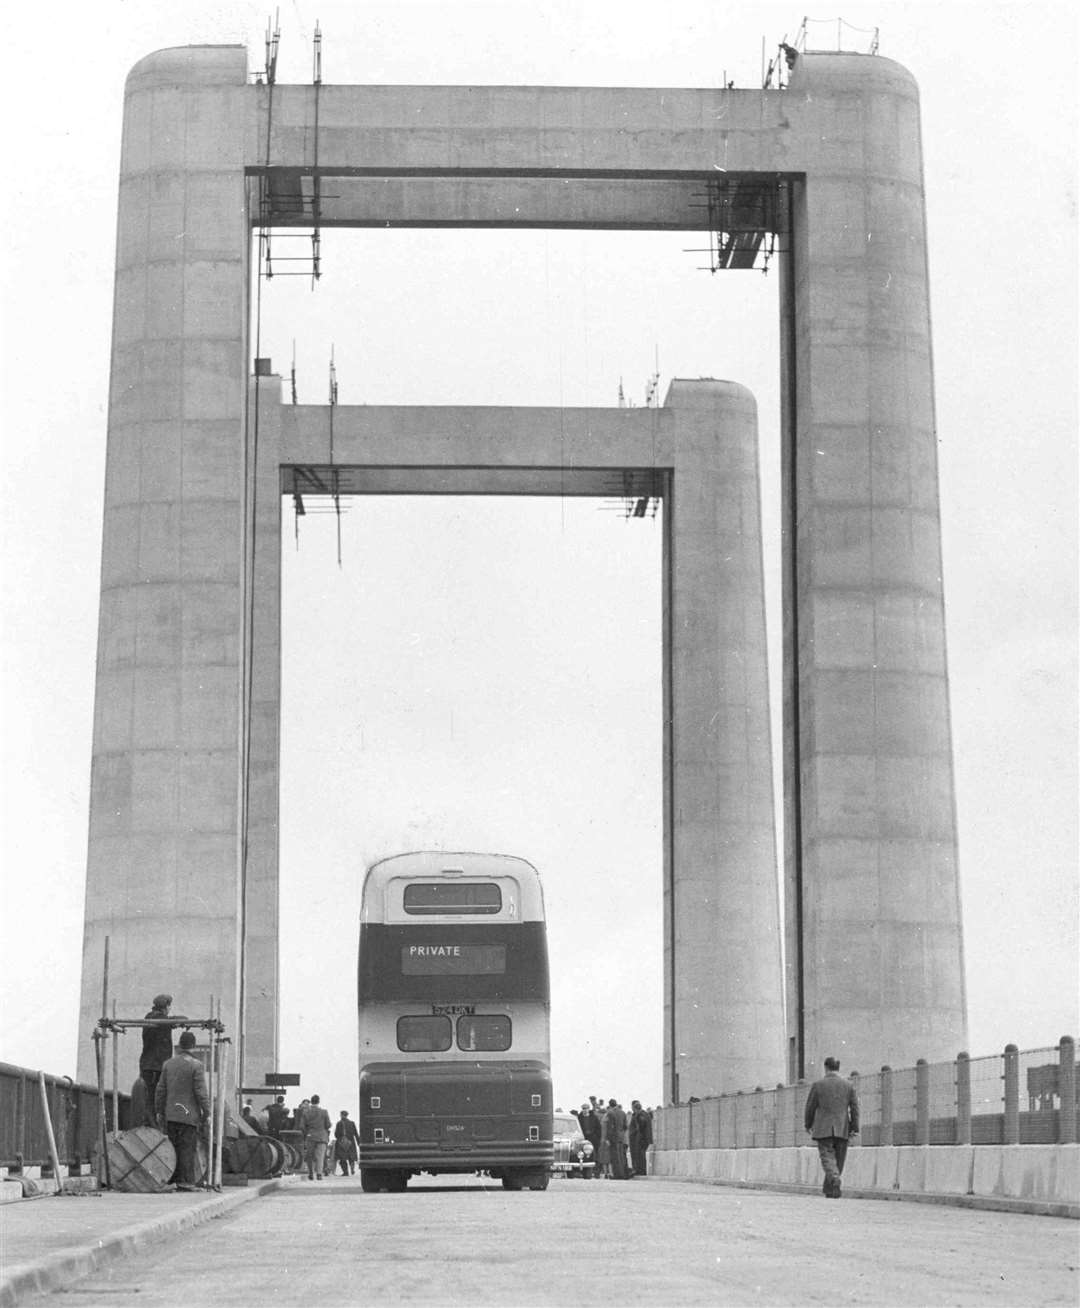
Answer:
[{"xmin": 40, "ymin": 1179, "xmax": 1080, "ymax": 1308}]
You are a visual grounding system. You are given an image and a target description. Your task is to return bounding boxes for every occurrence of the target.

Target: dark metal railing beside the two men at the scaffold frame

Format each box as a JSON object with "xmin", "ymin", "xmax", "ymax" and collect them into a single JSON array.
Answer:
[{"xmin": 0, "ymin": 1062, "xmax": 131, "ymax": 1173}]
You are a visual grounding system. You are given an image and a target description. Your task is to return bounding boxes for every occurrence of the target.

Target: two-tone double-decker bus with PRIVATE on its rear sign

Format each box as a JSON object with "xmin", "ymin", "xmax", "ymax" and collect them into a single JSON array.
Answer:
[{"xmin": 357, "ymin": 853, "xmax": 553, "ymax": 1190}]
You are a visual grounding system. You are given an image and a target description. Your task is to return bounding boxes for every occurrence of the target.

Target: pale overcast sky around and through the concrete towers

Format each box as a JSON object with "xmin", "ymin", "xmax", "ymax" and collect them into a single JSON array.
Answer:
[{"xmin": 0, "ymin": 0, "xmax": 1080, "ymax": 1110}]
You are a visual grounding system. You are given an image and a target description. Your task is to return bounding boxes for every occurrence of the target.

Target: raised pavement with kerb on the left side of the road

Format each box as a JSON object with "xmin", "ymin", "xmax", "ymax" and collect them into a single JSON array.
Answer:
[{"xmin": 0, "ymin": 1179, "xmax": 290, "ymax": 1308}]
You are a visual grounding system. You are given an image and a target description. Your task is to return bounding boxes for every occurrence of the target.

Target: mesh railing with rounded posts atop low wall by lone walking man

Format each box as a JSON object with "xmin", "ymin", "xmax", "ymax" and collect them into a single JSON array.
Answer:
[{"xmin": 654, "ymin": 1036, "xmax": 1077, "ymax": 1150}]
